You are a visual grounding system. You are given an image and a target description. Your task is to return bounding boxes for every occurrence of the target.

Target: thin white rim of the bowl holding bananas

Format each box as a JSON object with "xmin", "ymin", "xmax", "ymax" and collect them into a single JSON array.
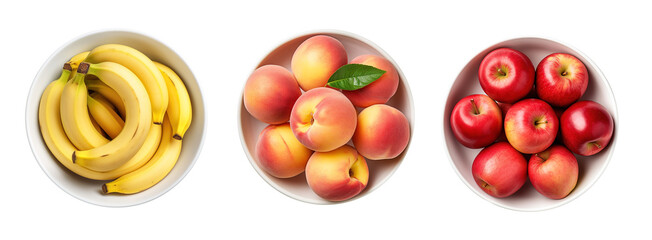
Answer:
[{"xmin": 25, "ymin": 28, "xmax": 208, "ymax": 208}]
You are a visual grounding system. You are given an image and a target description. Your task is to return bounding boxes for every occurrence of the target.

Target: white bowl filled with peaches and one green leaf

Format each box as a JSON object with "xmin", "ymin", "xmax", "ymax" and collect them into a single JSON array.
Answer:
[{"xmin": 238, "ymin": 31, "xmax": 414, "ymax": 204}]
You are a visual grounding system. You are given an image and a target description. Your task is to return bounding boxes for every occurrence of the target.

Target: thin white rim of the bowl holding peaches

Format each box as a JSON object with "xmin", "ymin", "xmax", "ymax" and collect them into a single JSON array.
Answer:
[{"xmin": 236, "ymin": 29, "xmax": 416, "ymax": 205}]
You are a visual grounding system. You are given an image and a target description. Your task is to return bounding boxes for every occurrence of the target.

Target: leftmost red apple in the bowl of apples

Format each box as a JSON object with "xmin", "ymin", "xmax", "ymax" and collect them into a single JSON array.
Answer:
[{"xmin": 450, "ymin": 94, "xmax": 503, "ymax": 148}]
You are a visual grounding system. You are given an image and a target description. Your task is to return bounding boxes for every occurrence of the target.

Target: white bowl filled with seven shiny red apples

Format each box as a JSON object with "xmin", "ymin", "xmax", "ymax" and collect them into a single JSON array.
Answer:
[{"xmin": 444, "ymin": 38, "xmax": 618, "ymax": 211}]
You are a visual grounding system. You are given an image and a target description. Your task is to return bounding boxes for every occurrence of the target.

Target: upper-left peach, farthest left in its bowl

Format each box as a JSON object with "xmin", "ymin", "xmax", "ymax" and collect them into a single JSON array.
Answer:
[{"xmin": 243, "ymin": 65, "xmax": 301, "ymax": 124}]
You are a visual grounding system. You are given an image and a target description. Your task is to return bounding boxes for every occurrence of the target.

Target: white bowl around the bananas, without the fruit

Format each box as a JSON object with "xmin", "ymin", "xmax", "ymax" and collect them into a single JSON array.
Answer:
[{"xmin": 25, "ymin": 31, "xmax": 205, "ymax": 207}]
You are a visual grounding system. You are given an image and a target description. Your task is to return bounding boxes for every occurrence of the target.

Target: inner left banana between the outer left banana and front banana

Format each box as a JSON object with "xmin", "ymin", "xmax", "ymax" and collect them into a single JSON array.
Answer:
[{"xmin": 60, "ymin": 63, "xmax": 109, "ymax": 150}]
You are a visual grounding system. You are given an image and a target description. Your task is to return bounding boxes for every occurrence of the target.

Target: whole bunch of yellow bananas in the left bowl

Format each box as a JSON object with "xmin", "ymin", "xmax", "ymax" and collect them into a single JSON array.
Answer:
[{"xmin": 39, "ymin": 44, "xmax": 192, "ymax": 194}]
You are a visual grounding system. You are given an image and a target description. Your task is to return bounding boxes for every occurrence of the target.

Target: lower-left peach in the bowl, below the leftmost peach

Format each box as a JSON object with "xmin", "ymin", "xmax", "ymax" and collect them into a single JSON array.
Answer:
[{"xmin": 255, "ymin": 123, "xmax": 312, "ymax": 178}]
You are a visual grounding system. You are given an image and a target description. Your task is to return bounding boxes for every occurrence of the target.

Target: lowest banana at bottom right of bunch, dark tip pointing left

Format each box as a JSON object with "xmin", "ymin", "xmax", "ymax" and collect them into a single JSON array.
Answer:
[{"xmin": 102, "ymin": 116, "xmax": 181, "ymax": 194}]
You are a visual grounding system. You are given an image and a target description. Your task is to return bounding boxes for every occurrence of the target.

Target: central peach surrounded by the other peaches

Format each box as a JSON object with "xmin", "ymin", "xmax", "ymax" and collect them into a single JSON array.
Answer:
[{"xmin": 290, "ymin": 87, "xmax": 358, "ymax": 152}]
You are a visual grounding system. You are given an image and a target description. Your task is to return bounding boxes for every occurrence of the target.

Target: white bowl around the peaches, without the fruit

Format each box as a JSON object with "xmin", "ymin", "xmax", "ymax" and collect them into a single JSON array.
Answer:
[{"xmin": 238, "ymin": 31, "xmax": 414, "ymax": 204}]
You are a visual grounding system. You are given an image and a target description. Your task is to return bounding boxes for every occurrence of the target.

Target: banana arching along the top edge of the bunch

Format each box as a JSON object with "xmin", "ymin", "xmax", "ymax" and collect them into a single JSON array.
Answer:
[{"xmin": 84, "ymin": 44, "xmax": 168, "ymax": 124}]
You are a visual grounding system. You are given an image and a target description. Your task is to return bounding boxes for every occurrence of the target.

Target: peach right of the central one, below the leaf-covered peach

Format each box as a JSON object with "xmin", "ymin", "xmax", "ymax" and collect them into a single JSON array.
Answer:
[{"xmin": 353, "ymin": 104, "xmax": 410, "ymax": 160}]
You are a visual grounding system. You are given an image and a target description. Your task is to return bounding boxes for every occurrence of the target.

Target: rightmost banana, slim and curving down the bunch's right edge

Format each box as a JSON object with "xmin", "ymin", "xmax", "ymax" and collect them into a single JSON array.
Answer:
[{"xmin": 154, "ymin": 62, "xmax": 192, "ymax": 140}]
